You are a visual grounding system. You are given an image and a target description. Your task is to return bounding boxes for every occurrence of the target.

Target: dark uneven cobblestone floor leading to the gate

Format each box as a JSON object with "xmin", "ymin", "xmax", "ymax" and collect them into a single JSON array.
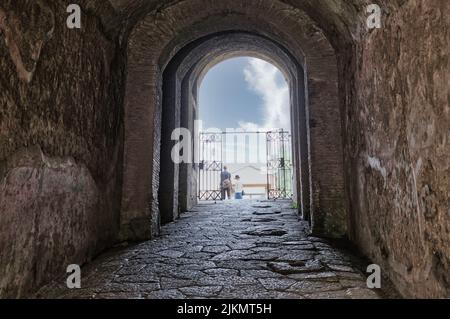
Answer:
[{"xmin": 36, "ymin": 201, "xmax": 379, "ymax": 299}]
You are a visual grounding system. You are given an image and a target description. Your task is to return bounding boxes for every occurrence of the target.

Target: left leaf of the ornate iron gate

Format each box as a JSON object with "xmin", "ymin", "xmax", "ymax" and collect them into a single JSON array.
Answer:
[{"xmin": 198, "ymin": 133, "xmax": 223, "ymax": 201}]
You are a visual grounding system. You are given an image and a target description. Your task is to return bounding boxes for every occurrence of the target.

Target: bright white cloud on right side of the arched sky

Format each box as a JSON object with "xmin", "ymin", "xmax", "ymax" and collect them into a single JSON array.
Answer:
[{"xmin": 244, "ymin": 58, "xmax": 291, "ymax": 130}]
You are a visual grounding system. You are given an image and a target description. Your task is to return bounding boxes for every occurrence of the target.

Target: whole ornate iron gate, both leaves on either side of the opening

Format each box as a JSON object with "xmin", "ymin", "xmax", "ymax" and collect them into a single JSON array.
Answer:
[{"xmin": 197, "ymin": 130, "xmax": 293, "ymax": 201}]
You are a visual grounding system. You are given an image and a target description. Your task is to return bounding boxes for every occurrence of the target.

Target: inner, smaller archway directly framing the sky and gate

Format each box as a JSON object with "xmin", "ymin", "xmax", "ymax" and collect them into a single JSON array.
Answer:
[{"xmin": 160, "ymin": 32, "xmax": 311, "ymax": 228}]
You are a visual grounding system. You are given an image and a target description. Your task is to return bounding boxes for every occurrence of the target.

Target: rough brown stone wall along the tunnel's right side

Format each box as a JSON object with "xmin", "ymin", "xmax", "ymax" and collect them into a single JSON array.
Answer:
[{"xmin": 344, "ymin": 0, "xmax": 450, "ymax": 297}]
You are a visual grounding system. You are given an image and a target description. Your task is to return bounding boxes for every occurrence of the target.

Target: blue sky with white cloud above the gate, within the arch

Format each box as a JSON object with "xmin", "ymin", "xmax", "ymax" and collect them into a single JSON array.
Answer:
[{"xmin": 199, "ymin": 57, "xmax": 289, "ymax": 130}]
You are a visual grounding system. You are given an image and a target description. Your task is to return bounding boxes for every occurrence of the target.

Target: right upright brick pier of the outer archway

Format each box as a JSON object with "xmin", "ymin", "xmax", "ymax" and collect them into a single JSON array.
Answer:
[{"xmin": 307, "ymin": 49, "xmax": 347, "ymax": 238}]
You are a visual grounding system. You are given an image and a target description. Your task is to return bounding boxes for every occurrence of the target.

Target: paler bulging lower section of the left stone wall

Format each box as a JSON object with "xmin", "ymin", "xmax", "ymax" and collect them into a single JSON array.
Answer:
[{"xmin": 0, "ymin": 147, "xmax": 118, "ymax": 298}]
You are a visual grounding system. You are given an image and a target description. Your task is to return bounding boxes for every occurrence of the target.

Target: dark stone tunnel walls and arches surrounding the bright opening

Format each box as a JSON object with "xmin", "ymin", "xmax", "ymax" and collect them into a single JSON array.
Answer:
[{"xmin": 0, "ymin": 0, "xmax": 450, "ymax": 298}]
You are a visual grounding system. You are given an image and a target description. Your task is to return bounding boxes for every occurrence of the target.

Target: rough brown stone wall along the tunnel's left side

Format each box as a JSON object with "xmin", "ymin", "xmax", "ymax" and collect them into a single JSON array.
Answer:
[{"xmin": 0, "ymin": 0, "xmax": 123, "ymax": 297}]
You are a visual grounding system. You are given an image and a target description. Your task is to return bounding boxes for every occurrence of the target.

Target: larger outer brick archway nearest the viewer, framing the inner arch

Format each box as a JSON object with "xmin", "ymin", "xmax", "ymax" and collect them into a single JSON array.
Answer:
[{"xmin": 121, "ymin": 1, "xmax": 347, "ymax": 239}]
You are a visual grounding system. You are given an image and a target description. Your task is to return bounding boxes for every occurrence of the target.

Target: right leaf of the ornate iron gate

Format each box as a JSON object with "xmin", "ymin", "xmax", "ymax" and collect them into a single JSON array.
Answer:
[{"xmin": 266, "ymin": 130, "xmax": 293, "ymax": 199}]
